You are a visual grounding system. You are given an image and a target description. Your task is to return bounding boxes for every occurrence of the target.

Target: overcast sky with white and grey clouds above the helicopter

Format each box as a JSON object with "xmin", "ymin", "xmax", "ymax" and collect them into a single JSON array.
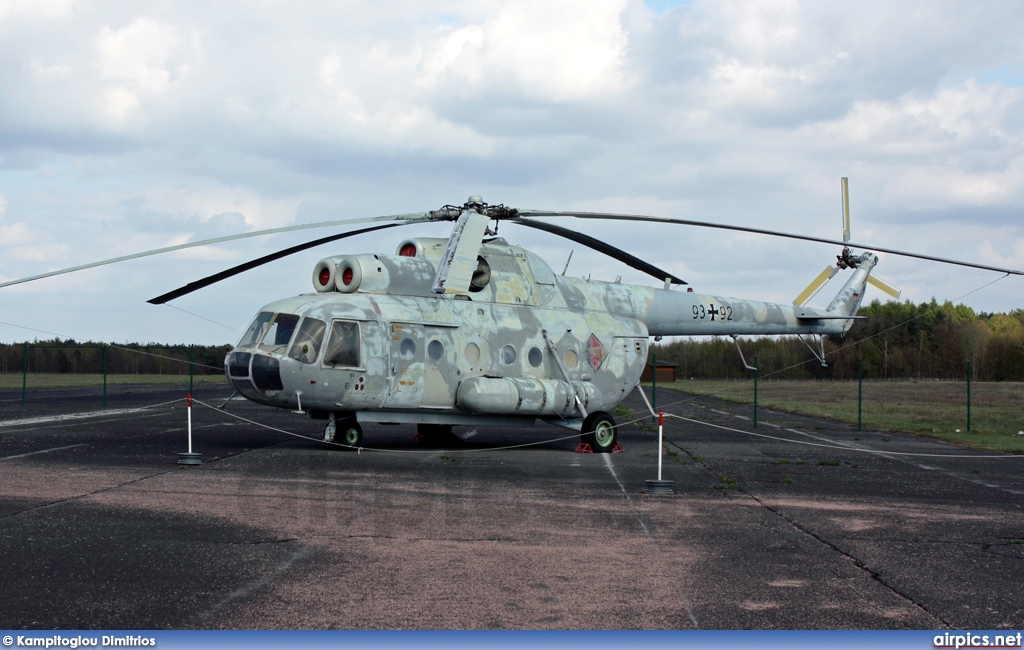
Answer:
[{"xmin": 0, "ymin": 0, "xmax": 1024, "ymax": 343}]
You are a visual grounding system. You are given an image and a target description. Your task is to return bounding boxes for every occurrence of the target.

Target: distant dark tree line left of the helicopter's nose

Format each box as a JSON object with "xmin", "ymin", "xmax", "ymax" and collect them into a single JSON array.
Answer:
[{"xmin": 0, "ymin": 339, "xmax": 231, "ymax": 376}]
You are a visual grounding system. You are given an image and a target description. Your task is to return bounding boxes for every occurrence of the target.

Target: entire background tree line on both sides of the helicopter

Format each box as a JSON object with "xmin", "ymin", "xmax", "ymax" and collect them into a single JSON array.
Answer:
[{"xmin": 0, "ymin": 299, "xmax": 1024, "ymax": 382}]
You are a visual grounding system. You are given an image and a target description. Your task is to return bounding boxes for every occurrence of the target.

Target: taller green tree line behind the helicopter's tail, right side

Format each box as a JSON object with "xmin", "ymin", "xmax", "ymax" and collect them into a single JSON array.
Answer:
[{"xmin": 651, "ymin": 299, "xmax": 1024, "ymax": 382}]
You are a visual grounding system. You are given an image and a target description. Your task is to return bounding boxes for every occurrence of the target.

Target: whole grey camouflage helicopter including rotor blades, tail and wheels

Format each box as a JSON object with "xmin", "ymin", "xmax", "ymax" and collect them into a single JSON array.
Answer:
[{"xmin": 0, "ymin": 179, "xmax": 1024, "ymax": 452}]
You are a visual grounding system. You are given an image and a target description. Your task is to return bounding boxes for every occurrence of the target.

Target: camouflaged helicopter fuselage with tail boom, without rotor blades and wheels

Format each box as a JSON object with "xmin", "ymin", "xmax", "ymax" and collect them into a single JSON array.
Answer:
[{"xmin": 225, "ymin": 239, "xmax": 869, "ymax": 444}]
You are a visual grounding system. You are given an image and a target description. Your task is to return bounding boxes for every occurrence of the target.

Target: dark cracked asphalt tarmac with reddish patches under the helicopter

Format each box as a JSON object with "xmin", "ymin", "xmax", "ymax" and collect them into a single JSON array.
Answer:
[{"xmin": 0, "ymin": 388, "xmax": 1024, "ymax": 630}]
